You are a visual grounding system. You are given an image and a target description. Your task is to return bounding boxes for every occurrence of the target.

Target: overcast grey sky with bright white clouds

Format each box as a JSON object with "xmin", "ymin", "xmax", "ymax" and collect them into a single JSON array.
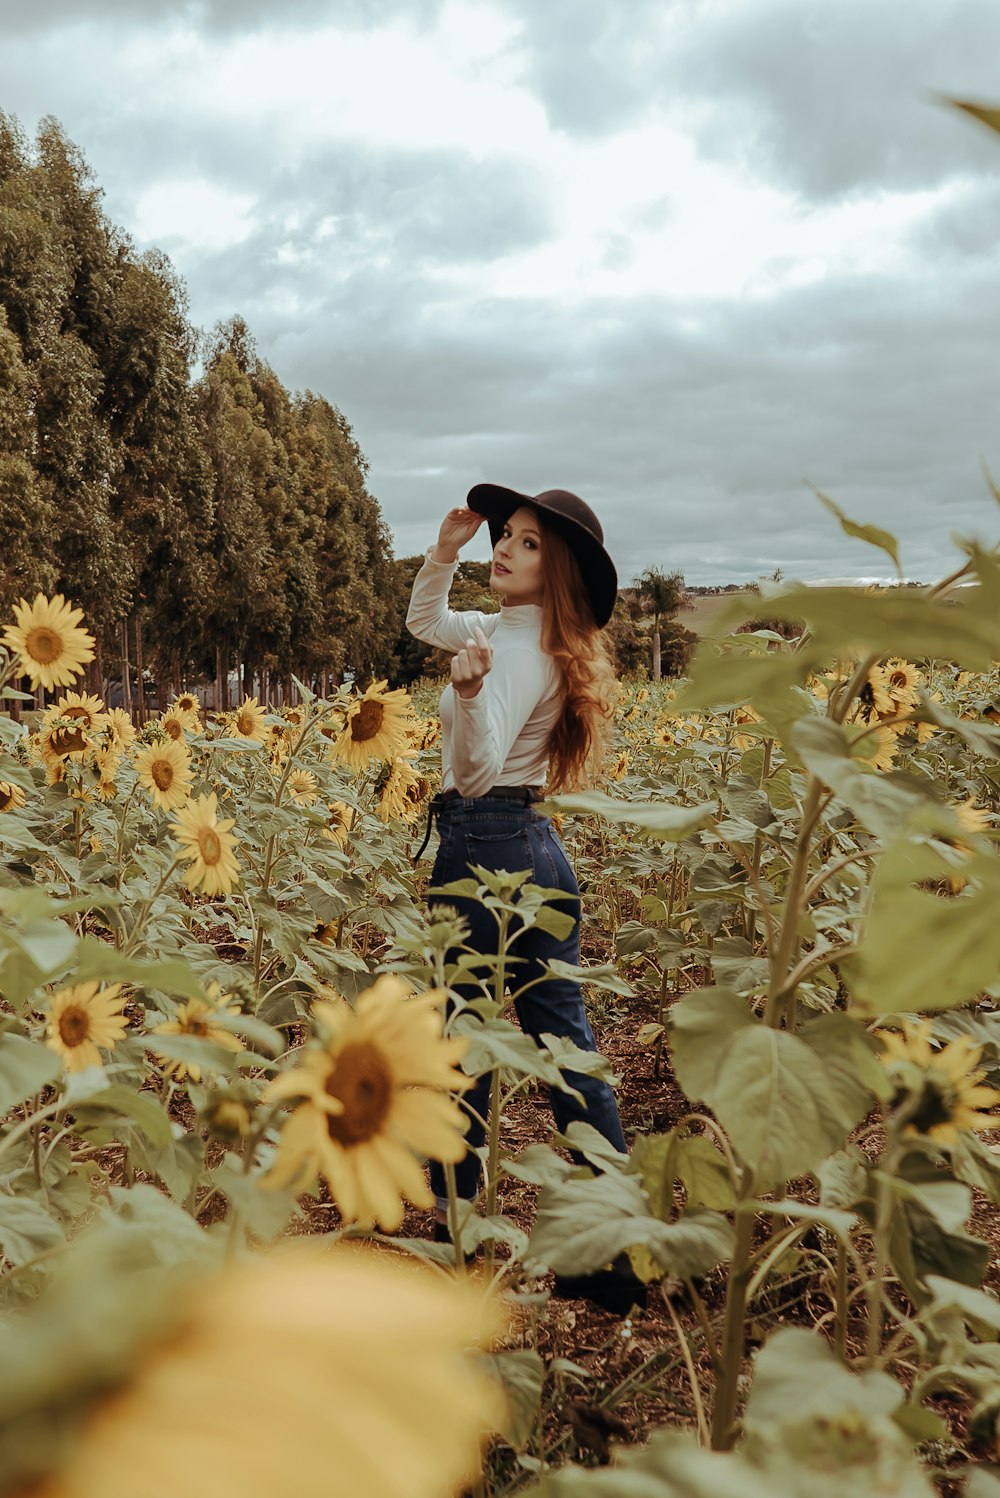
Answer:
[{"xmin": 0, "ymin": 0, "xmax": 1000, "ymax": 583}]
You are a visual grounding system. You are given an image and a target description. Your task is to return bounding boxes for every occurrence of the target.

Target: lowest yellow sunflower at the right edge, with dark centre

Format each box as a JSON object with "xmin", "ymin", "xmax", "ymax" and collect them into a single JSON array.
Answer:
[{"xmin": 877, "ymin": 1020, "xmax": 1000, "ymax": 1144}]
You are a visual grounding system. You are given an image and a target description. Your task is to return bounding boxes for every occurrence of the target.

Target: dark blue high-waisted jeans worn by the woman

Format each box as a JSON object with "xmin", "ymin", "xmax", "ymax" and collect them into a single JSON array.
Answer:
[{"xmin": 428, "ymin": 797, "xmax": 626, "ymax": 1200}]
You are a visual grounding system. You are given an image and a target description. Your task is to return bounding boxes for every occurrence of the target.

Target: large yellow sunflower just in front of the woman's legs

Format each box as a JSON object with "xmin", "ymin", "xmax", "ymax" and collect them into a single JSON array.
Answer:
[{"xmin": 266, "ymin": 974, "xmax": 472, "ymax": 1233}]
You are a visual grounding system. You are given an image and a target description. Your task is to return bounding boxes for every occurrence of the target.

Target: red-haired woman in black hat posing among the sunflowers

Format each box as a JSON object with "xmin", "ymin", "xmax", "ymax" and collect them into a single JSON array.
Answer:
[{"xmin": 406, "ymin": 484, "xmax": 644, "ymax": 1311}]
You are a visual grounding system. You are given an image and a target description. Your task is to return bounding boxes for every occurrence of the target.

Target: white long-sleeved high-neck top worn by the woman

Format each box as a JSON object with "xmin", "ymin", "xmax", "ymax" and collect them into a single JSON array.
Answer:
[{"xmin": 406, "ymin": 553, "xmax": 561, "ymax": 795}]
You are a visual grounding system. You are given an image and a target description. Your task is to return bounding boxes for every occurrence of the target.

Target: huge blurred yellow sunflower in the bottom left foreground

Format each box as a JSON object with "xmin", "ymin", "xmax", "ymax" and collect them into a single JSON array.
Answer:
[{"xmin": 33, "ymin": 1245, "xmax": 503, "ymax": 1498}]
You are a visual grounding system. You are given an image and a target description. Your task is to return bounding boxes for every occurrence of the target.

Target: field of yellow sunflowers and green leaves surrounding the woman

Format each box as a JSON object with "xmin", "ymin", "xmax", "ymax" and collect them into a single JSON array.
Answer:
[{"xmin": 0, "ymin": 517, "xmax": 1000, "ymax": 1498}]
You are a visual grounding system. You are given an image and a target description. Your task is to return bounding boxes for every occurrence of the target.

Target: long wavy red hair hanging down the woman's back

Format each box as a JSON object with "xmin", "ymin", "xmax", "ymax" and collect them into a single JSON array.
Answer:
[{"xmin": 539, "ymin": 514, "xmax": 618, "ymax": 792}]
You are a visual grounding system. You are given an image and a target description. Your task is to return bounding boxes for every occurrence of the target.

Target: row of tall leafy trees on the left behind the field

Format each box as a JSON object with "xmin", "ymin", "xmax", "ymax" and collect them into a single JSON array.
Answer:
[{"xmin": 0, "ymin": 115, "xmax": 403, "ymax": 707}]
